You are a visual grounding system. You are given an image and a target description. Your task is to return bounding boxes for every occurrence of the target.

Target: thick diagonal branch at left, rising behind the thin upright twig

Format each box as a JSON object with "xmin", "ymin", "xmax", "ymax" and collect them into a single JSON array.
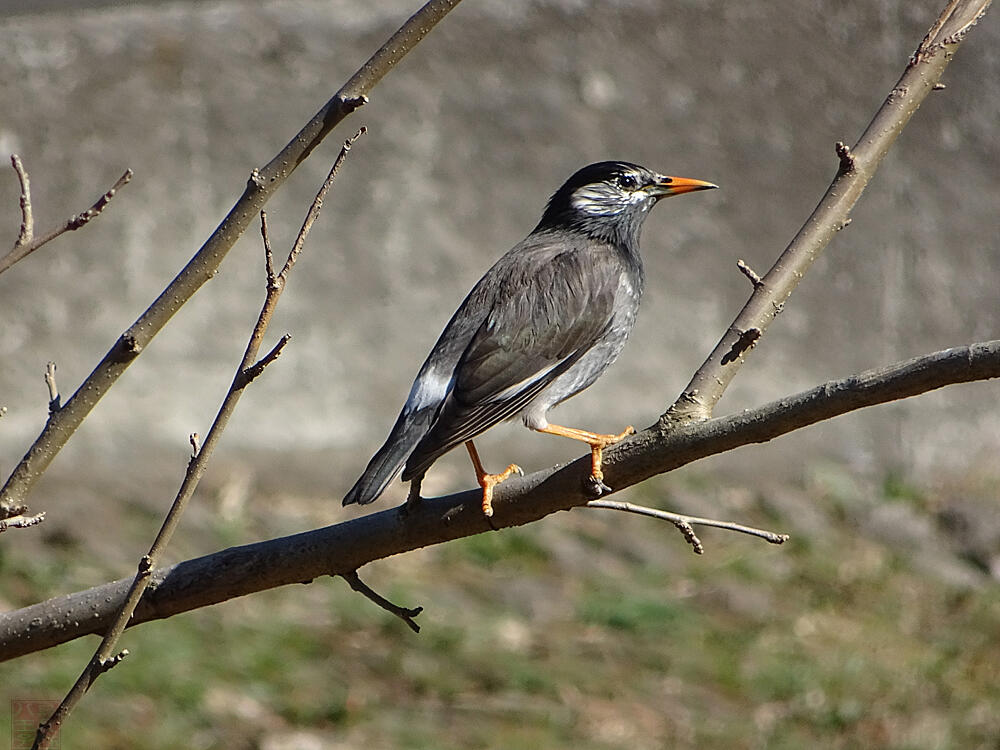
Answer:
[{"xmin": 0, "ymin": 0, "xmax": 461, "ymax": 519}]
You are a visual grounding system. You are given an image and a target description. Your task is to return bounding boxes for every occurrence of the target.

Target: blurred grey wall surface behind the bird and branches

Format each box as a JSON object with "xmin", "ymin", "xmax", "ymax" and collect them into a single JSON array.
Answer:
[{"xmin": 0, "ymin": 0, "xmax": 1000, "ymax": 506}]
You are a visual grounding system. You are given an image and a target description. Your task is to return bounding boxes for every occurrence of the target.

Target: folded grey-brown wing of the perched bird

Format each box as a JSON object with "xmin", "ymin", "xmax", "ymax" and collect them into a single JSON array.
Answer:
[{"xmin": 403, "ymin": 234, "xmax": 620, "ymax": 481}]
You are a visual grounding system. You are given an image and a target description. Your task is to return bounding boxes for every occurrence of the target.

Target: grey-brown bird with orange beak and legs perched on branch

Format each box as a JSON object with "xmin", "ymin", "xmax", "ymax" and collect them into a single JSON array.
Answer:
[{"xmin": 343, "ymin": 161, "xmax": 718, "ymax": 525}]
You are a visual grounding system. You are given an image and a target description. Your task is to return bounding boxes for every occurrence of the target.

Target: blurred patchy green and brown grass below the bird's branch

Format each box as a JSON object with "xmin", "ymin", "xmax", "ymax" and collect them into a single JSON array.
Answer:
[{"xmin": 0, "ymin": 466, "xmax": 1000, "ymax": 750}]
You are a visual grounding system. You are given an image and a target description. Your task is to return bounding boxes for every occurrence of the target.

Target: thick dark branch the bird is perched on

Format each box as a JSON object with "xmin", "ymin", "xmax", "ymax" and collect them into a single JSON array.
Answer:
[{"xmin": 0, "ymin": 340, "xmax": 1000, "ymax": 660}]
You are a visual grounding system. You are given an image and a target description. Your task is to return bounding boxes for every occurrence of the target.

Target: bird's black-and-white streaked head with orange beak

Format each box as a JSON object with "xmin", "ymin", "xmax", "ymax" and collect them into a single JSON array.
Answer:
[{"xmin": 535, "ymin": 161, "xmax": 718, "ymax": 246}]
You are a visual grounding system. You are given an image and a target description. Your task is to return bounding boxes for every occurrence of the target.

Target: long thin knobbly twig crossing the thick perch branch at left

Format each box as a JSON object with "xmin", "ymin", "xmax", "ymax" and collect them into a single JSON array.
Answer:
[{"xmin": 34, "ymin": 126, "xmax": 368, "ymax": 750}]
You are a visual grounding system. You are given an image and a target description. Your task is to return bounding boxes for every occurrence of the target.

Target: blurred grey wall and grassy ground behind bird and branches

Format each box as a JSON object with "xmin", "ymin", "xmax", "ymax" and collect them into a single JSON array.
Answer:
[{"xmin": 0, "ymin": 0, "xmax": 1000, "ymax": 750}]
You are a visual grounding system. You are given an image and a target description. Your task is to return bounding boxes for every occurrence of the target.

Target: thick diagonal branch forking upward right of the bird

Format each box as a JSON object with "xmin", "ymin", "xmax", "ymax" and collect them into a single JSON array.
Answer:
[{"xmin": 660, "ymin": 0, "xmax": 991, "ymax": 425}]
